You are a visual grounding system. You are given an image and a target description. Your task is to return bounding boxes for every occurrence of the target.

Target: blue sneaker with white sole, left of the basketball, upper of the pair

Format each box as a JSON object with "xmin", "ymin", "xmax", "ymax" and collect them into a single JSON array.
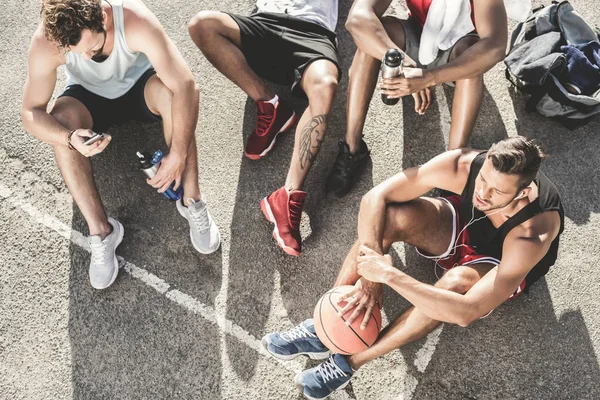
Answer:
[{"xmin": 261, "ymin": 318, "xmax": 329, "ymax": 360}]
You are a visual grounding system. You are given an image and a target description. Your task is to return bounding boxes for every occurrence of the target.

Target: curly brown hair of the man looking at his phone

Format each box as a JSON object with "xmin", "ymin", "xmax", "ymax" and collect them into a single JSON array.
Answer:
[{"xmin": 40, "ymin": 0, "xmax": 104, "ymax": 49}]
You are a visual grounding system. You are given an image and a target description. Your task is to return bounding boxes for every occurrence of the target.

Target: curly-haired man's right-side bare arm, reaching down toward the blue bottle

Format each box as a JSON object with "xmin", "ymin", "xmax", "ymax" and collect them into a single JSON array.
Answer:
[{"xmin": 125, "ymin": 4, "xmax": 200, "ymax": 159}]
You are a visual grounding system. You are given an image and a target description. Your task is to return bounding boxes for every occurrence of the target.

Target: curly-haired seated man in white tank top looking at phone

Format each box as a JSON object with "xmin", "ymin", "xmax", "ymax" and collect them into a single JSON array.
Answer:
[{"xmin": 21, "ymin": 0, "xmax": 220, "ymax": 289}]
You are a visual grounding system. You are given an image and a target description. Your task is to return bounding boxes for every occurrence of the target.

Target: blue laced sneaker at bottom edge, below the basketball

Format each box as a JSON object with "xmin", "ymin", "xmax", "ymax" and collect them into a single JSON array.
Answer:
[{"xmin": 294, "ymin": 354, "xmax": 352, "ymax": 400}]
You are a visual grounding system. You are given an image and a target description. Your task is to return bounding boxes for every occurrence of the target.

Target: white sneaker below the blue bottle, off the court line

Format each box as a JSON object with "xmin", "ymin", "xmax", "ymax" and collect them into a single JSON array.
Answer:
[{"xmin": 177, "ymin": 196, "xmax": 221, "ymax": 254}]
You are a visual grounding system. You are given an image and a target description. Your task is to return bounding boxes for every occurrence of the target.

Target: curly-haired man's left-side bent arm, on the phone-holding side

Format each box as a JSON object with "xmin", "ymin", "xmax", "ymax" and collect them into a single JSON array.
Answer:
[{"xmin": 21, "ymin": 29, "xmax": 70, "ymax": 146}]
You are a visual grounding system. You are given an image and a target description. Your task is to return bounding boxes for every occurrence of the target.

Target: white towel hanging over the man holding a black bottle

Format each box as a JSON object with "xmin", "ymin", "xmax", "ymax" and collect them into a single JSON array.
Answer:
[{"xmin": 419, "ymin": 0, "xmax": 531, "ymax": 65}]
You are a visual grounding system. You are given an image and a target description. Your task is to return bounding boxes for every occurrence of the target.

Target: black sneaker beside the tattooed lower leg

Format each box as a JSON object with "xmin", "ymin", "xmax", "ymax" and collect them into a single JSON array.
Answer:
[{"xmin": 325, "ymin": 139, "xmax": 369, "ymax": 197}]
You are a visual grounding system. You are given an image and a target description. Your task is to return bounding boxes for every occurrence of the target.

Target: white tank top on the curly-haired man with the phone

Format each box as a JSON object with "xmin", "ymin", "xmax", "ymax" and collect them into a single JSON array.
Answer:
[{"xmin": 66, "ymin": 0, "xmax": 152, "ymax": 99}]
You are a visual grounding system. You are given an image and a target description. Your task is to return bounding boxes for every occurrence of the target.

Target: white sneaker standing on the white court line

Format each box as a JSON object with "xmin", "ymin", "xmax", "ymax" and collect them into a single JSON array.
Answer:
[{"xmin": 88, "ymin": 217, "xmax": 125, "ymax": 289}]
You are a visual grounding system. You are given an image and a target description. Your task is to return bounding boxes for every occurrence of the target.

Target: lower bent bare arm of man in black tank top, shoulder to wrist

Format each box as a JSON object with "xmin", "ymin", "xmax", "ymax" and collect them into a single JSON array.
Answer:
[{"xmin": 385, "ymin": 212, "xmax": 560, "ymax": 326}]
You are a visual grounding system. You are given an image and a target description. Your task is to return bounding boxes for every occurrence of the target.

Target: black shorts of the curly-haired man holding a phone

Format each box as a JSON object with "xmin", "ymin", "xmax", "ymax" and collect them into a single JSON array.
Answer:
[{"xmin": 59, "ymin": 68, "xmax": 162, "ymax": 132}]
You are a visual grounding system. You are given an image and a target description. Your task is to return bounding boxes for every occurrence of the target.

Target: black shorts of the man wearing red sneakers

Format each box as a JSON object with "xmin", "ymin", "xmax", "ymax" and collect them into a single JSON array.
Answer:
[{"xmin": 226, "ymin": 13, "xmax": 342, "ymax": 96}]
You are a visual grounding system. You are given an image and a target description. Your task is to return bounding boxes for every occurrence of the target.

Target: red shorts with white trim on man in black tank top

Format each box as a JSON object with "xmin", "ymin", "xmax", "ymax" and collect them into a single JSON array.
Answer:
[{"xmin": 416, "ymin": 195, "xmax": 526, "ymax": 299}]
